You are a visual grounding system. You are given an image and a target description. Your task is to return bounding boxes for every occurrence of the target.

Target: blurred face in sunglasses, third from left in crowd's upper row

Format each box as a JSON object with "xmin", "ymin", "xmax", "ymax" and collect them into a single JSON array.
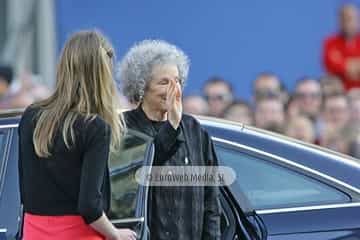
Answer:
[{"xmin": 295, "ymin": 78, "xmax": 322, "ymax": 123}]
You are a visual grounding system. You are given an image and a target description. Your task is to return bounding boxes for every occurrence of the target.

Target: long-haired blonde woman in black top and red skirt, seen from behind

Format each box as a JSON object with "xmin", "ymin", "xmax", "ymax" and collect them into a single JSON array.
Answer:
[{"xmin": 19, "ymin": 31, "xmax": 136, "ymax": 240}]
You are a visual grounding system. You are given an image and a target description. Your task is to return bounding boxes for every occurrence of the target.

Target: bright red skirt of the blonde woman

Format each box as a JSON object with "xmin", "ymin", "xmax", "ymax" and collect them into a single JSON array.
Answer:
[{"xmin": 23, "ymin": 213, "xmax": 105, "ymax": 240}]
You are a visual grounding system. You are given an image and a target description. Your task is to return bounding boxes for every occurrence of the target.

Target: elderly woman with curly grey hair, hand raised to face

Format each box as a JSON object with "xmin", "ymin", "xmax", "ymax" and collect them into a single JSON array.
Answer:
[{"xmin": 119, "ymin": 40, "xmax": 220, "ymax": 240}]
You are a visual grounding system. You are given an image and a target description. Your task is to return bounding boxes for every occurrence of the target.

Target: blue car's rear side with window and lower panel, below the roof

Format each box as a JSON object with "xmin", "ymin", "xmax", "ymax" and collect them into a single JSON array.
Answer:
[{"xmin": 214, "ymin": 139, "xmax": 360, "ymax": 240}]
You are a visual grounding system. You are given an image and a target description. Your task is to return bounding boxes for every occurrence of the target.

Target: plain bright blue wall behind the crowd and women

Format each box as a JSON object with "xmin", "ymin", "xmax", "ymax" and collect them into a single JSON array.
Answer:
[{"xmin": 56, "ymin": 0, "xmax": 360, "ymax": 98}]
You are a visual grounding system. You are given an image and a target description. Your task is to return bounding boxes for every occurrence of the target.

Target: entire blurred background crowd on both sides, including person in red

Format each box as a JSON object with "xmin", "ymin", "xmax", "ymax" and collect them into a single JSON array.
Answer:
[{"xmin": 0, "ymin": 4, "xmax": 360, "ymax": 158}]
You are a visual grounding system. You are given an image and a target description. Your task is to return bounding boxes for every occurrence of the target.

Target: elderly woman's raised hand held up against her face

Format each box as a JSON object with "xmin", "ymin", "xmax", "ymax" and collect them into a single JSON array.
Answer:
[{"xmin": 166, "ymin": 80, "xmax": 182, "ymax": 129}]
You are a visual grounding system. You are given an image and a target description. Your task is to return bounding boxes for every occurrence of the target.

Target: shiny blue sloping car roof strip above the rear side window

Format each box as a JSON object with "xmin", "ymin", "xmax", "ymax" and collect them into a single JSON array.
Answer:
[{"xmin": 196, "ymin": 116, "xmax": 360, "ymax": 189}]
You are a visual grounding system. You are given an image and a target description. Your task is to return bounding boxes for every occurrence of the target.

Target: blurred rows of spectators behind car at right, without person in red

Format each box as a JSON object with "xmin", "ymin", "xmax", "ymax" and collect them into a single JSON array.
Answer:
[{"xmin": 183, "ymin": 73, "xmax": 360, "ymax": 158}]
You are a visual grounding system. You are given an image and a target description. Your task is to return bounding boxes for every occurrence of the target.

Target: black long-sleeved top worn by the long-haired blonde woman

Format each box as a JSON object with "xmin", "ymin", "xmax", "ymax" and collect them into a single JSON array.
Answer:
[{"xmin": 19, "ymin": 108, "xmax": 111, "ymax": 224}]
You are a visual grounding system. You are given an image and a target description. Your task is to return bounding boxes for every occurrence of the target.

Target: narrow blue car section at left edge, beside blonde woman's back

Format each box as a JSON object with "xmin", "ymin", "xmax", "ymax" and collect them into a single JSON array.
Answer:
[{"xmin": 0, "ymin": 124, "xmax": 21, "ymax": 240}]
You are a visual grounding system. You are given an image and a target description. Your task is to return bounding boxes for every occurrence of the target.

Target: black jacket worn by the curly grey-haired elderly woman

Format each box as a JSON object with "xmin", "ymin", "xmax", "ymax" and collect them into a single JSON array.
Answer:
[{"xmin": 124, "ymin": 107, "xmax": 220, "ymax": 240}]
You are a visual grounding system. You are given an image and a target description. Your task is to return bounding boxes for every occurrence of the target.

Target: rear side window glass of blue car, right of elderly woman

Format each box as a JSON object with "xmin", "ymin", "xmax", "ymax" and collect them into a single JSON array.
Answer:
[{"xmin": 216, "ymin": 145, "xmax": 350, "ymax": 210}]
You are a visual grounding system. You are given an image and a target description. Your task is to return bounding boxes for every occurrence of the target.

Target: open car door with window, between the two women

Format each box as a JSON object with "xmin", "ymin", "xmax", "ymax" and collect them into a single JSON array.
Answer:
[{"xmin": 109, "ymin": 129, "xmax": 154, "ymax": 240}]
